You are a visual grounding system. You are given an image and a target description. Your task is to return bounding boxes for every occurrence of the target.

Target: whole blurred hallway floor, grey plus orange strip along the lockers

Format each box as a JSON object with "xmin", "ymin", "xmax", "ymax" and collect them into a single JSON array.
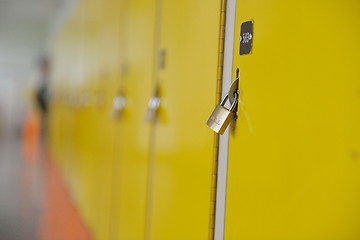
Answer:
[{"xmin": 0, "ymin": 134, "xmax": 91, "ymax": 240}]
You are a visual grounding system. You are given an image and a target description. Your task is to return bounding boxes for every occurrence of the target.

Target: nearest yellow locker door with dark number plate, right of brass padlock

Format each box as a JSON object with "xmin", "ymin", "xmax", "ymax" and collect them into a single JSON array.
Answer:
[{"xmin": 225, "ymin": 0, "xmax": 360, "ymax": 240}]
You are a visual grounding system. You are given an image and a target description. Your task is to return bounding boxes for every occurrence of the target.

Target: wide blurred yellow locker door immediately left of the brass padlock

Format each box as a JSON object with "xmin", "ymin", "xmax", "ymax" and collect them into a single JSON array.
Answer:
[{"xmin": 147, "ymin": 0, "xmax": 220, "ymax": 240}]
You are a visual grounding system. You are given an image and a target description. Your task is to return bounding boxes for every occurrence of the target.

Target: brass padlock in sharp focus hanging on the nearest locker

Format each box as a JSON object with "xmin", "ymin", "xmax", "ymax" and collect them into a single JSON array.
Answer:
[{"xmin": 206, "ymin": 92, "xmax": 238, "ymax": 134}]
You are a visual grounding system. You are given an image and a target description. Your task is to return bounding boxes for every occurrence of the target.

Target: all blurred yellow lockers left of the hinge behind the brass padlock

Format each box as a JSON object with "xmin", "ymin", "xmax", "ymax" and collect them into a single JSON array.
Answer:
[{"xmin": 51, "ymin": 0, "xmax": 221, "ymax": 240}]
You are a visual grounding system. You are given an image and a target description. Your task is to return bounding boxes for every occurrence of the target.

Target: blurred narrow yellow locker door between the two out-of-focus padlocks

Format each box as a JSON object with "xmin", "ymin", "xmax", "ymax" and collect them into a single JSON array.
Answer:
[{"xmin": 111, "ymin": 0, "xmax": 156, "ymax": 240}]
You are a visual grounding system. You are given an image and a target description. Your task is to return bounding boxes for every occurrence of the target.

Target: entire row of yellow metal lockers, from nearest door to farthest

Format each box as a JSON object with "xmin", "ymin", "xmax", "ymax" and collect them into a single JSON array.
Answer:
[{"xmin": 50, "ymin": 0, "xmax": 360, "ymax": 240}]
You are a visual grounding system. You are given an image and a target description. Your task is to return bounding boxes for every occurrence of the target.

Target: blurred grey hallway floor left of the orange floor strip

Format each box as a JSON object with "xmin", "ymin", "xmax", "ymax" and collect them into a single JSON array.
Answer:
[{"xmin": 0, "ymin": 136, "xmax": 42, "ymax": 240}]
